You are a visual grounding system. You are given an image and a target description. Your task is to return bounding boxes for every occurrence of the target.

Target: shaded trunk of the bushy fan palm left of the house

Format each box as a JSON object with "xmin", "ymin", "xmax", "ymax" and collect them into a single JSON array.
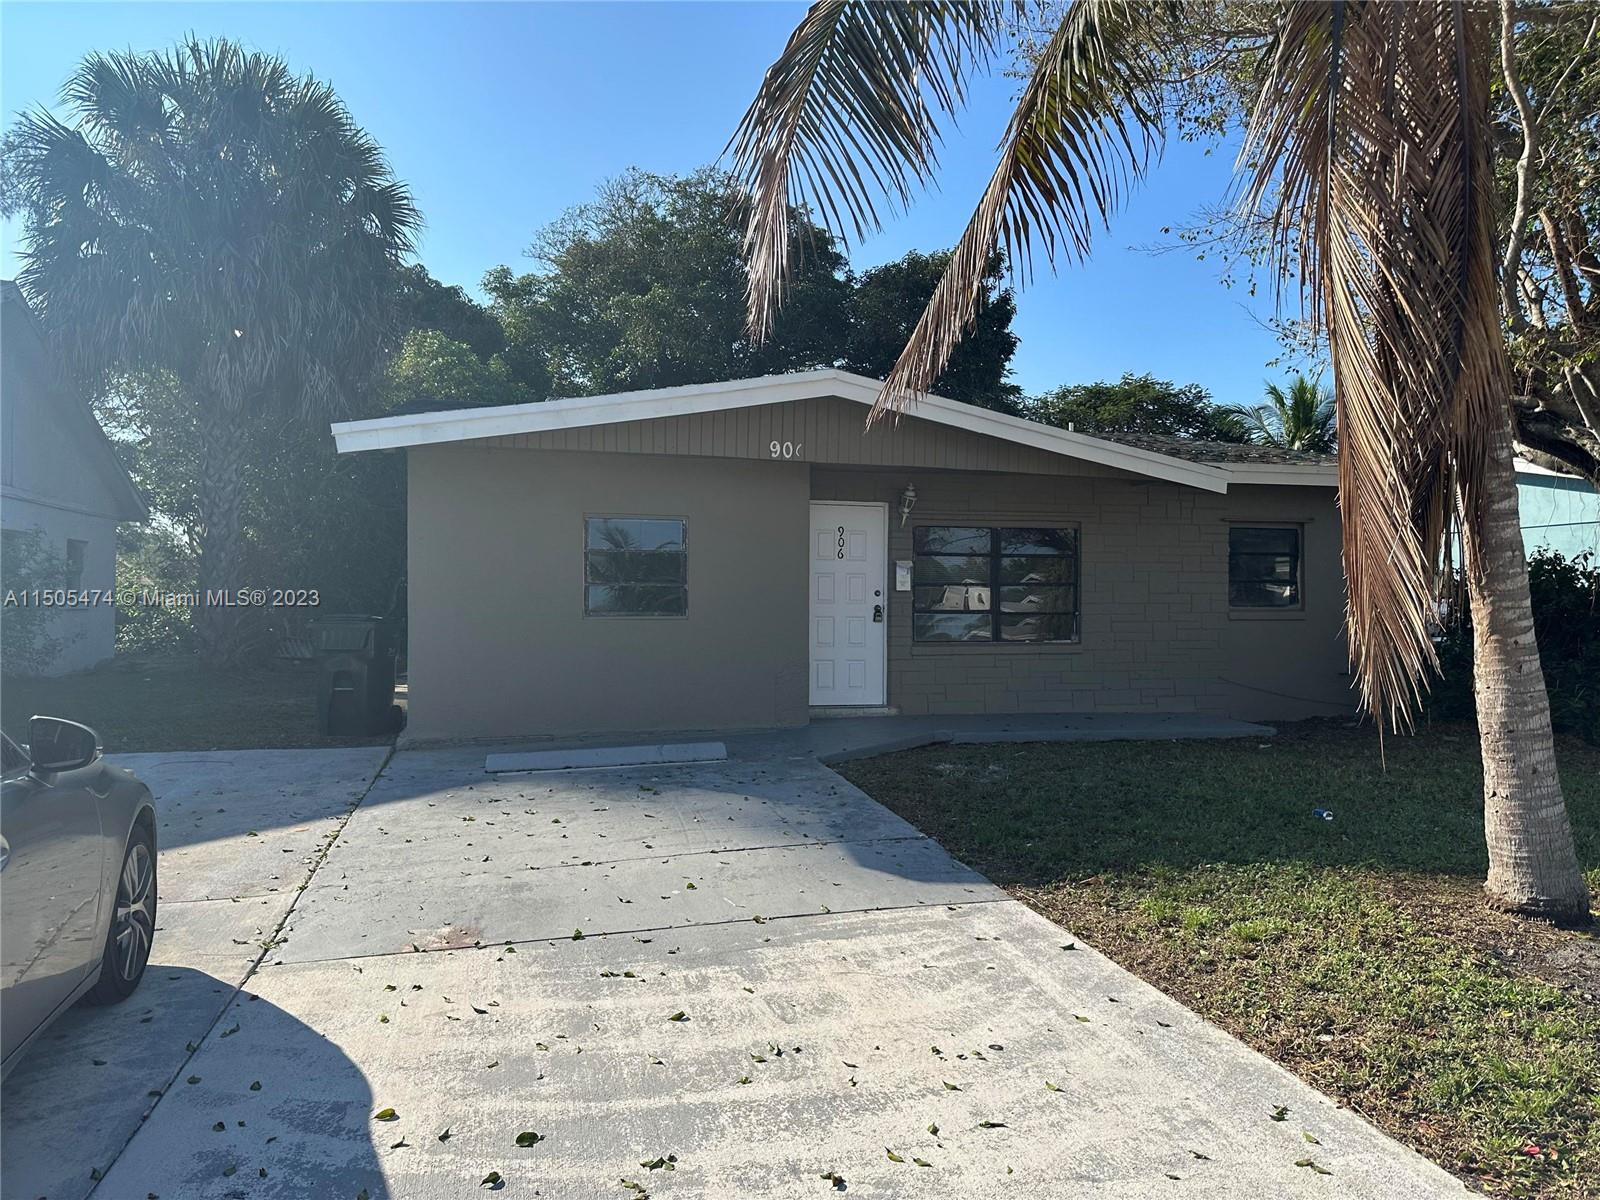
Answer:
[{"xmin": 195, "ymin": 397, "xmax": 246, "ymax": 667}]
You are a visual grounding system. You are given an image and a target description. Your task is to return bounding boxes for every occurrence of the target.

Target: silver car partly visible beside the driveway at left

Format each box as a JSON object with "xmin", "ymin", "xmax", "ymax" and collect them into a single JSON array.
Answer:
[{"xmin": 0, "ymin": 717, "xmax": 155, "ymax": 1075}]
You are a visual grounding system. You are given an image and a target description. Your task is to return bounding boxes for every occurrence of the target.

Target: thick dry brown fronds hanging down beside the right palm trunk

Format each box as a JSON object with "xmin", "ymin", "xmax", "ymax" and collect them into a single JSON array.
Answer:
[{"xmin": 1242, "ymin": 2, "xmax": 1509, "ymax": 726}]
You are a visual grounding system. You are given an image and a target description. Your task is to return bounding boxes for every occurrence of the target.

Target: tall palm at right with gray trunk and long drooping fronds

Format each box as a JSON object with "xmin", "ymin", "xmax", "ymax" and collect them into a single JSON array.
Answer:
[{"xmin": 730, "ymin": 0, "xmax": 1589, "ymax": 922}]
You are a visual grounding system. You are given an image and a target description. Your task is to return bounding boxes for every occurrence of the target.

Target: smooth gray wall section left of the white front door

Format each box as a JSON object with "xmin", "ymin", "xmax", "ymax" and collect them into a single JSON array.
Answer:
[{"xmin": 406, "ymin": 445, "xmax": 810, "ymax": 741}]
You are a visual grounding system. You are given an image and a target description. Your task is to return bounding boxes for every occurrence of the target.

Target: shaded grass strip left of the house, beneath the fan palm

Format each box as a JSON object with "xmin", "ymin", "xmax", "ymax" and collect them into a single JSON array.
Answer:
[{"xmin": 0, "ymin": 658, "xmax": 386, "ymax": 754}]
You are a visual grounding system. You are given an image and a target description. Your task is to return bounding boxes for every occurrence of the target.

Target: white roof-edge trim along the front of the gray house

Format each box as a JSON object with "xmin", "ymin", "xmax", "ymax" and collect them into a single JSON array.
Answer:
[{"xmin": 333, "ymin": 368, "xmax": 1336, "ymax": 491}]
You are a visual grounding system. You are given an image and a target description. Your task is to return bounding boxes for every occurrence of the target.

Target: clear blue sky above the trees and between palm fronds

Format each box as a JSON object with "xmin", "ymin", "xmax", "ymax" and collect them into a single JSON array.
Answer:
[{"xmin": 0, "ymin": 0, "xmax": 1283, "ymax": 403}]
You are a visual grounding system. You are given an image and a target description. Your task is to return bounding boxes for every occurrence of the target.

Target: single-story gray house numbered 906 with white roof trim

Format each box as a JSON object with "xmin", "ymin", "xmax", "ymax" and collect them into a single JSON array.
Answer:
[{"xmin": 333, "ymin": 370, "xmax": 1355, "ymax": 741}]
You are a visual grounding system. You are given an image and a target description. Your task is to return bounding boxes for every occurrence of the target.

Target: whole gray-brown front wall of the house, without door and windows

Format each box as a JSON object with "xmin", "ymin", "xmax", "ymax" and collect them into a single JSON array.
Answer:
[{"xmin": 406, "ymin": 443, "xmax": 1354, "ymax": 741}]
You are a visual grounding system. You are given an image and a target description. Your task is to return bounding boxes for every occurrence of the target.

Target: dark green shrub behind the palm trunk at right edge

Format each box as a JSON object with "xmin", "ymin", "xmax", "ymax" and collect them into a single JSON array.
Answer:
[{"xmin": 1429, "ymin": 549, "xmax": 1600, "ymax": 744}]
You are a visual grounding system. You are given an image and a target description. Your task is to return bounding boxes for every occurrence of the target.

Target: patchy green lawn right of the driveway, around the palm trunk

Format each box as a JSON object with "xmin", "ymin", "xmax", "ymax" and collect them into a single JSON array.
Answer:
[{"xmin": 842, "ymin": 723, "xmax": 1600, "ymax": 1200}]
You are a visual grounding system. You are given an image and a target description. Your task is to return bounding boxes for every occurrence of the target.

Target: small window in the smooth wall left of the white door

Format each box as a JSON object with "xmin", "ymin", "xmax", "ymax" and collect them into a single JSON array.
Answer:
[{"xmin": 584, "ymin": 517, "xmax": 690, "ymax": 616}]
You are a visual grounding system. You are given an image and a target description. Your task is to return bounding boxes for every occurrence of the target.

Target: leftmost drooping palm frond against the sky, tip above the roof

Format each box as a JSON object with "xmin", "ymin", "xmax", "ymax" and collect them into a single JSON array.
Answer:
[{"xmin": 728, "ymin": 0, "xmax": 1019, "ymax": 341}]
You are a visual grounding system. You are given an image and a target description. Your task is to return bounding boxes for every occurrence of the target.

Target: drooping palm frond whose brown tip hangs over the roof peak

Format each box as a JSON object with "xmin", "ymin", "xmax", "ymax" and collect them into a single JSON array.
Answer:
[{"xmin": 872, "ymin": 0, "xmax": 1171, "ymax": 419}]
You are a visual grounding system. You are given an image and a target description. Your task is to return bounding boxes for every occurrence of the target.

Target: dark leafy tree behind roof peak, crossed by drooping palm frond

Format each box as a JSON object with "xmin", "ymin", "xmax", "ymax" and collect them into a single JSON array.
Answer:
[{"xmin": 845, "ymin": 250, "xmax": 1022, "ymax": 416}]
